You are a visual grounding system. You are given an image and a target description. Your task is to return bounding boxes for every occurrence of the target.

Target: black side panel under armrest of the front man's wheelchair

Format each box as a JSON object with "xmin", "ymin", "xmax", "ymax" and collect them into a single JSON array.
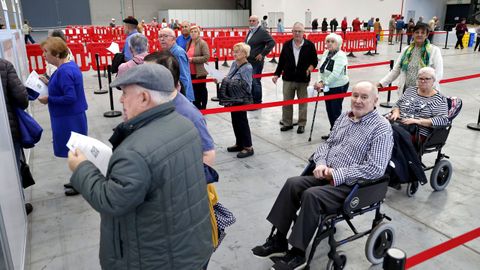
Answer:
[{"xmin": 343, "ymin": 174, "xmax": 390, "ymax": 218}]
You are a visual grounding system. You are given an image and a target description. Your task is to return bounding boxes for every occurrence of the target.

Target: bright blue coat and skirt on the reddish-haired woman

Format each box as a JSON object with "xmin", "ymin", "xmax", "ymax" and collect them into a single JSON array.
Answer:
[{"xmin": 48, "ymin": 61, "xmax": 88, "ymax": 157}]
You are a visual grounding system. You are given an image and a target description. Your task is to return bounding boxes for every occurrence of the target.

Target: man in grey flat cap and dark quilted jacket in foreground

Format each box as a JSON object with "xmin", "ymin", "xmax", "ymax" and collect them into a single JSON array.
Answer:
[{"xmin": 68, "ymin": 64, "xmax": 213, "ymax": 270}]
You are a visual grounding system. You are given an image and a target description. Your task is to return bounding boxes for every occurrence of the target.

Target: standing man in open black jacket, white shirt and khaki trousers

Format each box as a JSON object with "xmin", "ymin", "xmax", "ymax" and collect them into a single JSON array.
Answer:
[{"xmin": 272, "ymin": 22, "xmax": 318, "ymax": 134}]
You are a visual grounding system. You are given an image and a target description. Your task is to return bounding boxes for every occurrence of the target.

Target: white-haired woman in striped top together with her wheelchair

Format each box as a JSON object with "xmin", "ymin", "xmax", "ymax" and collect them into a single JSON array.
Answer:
[{"xmin": 387, "ymin": 67, "xmax": 462, "ymax": 196}]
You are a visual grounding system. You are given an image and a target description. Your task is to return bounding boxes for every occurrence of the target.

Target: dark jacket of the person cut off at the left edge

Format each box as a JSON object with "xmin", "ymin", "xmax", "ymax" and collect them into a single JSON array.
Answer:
[{"xmin": 0, "ymin": 58, "xmax": 28, "ymax": 142}]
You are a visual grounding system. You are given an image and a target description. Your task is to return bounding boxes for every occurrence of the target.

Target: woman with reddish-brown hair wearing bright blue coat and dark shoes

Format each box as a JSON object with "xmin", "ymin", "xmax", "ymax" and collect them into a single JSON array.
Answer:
[{"xmin": 38, "ymin": 37, "xmax": 88, "ymax": 196}]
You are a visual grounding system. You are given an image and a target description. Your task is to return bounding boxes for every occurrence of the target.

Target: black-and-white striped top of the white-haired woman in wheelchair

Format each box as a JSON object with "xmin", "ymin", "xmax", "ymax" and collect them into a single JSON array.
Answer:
[{"xmin": 394, "ymin": 87, "xmax": 450, "ymax": 136}]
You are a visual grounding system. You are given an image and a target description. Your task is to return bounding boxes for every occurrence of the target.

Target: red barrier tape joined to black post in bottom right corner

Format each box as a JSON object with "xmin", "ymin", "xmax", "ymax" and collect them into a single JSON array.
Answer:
[{"xmin": 405, "ymin": 227, "xmax": 480, "ymax": 269}]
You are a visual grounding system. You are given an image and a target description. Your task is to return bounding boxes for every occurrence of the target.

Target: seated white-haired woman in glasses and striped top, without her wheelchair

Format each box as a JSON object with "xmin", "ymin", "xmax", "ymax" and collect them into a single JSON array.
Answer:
[{"xmin": 387, "ymin": 67, "xmax": 450, "ymax": 142}]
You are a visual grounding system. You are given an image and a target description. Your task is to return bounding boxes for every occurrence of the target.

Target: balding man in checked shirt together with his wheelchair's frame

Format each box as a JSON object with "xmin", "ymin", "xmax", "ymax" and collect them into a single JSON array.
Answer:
[{"xmin": 252, "ymin": 82, "xmax": 393, "ymax": 270}]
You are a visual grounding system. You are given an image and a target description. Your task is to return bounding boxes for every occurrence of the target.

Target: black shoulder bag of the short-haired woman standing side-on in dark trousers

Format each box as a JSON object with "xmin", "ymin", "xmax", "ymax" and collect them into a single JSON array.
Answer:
[{"xmin": 218, "ymin": 63, "xmax": 253, "ymax": 107}]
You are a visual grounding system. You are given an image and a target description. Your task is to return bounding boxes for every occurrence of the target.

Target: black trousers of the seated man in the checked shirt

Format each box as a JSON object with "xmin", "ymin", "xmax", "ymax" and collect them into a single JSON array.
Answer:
[{"xmin": 267, "ymin": 176, "xmax": 352, "ymax": 250}]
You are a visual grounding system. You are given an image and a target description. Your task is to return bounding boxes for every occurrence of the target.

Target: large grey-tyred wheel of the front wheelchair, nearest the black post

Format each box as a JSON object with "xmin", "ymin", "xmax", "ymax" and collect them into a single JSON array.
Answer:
[{"xmin": 365, "ymin": 222, "xmax": 396, "ymax": 264}]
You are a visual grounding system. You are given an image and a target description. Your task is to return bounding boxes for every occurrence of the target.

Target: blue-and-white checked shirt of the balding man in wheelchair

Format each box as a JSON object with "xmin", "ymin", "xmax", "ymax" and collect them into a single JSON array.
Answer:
[{"xmin": 313, "ymin": 110, "xmax": 393, "ymax": 186}]
